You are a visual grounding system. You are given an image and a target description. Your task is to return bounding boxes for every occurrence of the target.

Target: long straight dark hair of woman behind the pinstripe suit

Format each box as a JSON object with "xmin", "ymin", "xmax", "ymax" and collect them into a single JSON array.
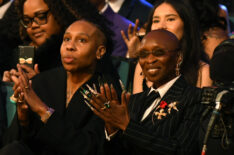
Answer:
[{"xmin": 146, "ymin": 0, "xmax": 206, "ymax": 86}]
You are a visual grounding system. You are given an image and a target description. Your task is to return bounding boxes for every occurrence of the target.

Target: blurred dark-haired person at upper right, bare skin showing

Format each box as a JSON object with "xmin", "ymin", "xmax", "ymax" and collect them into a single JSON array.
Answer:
[{"xmin": 186, "ymin": 0, "xmax": 230, "ymax": 59}]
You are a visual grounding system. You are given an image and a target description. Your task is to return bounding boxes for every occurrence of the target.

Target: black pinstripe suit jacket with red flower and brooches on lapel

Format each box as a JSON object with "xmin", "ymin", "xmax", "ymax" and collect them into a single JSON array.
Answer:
[{"xmin": 106, "ymin": 77, "xmax": 203, "ymax": 155}]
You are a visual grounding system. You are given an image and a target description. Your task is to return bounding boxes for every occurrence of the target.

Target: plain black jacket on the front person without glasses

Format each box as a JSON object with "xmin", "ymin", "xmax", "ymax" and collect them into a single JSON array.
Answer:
[{"xmin": 3, "ymin": 68, "xmax": 119, "ymax": 155}]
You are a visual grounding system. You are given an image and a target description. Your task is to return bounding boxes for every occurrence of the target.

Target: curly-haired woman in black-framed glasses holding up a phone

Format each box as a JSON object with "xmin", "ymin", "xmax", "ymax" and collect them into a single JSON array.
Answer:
[{"xmin": 3, "ymin": 0, "xmax": 99, "ymax": 82}]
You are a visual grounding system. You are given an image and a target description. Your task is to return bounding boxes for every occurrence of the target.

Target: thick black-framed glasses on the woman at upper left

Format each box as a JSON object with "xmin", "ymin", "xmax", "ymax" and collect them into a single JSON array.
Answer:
[{"xmin": 20, "ymin": 10, "xmax": 50, "ymax": 29}]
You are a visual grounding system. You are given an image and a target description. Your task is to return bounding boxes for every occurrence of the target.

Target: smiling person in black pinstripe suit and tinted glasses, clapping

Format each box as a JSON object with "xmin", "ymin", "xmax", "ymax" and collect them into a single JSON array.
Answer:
[{"xmin": 90, "ymin": 29, "xmax": 203, "ymax": 155}]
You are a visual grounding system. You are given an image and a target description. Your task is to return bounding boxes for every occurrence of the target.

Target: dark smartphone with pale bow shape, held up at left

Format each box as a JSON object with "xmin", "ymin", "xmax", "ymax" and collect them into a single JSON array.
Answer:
[{"xmin": 19, "ymin": 46, "xmax": 35, "ymax": 68}]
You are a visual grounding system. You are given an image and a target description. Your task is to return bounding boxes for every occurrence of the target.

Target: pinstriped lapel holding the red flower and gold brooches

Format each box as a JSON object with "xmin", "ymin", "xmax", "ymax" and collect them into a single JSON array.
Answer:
[{"xmin": 141, "ymin": 76, "xmax": 186, "ymax": 125}]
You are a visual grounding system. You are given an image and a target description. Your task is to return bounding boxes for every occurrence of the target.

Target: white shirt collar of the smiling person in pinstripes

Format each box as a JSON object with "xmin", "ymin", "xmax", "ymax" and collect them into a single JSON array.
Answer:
[{"xmin": 149, "ymin": 75, "xmax": 180, "ymax": 98}]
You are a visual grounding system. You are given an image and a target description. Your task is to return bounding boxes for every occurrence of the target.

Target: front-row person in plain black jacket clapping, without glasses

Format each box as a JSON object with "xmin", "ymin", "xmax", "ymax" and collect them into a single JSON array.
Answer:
[{"xmin": 0, "ymin": 18, "xmax": 120, "ymax": 155}]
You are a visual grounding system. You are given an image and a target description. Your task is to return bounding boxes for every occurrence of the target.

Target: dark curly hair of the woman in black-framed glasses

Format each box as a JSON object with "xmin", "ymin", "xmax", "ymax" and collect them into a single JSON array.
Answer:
[{"xmin": 15, "ymin": 0, "xmax": 103, "ymax": 41}]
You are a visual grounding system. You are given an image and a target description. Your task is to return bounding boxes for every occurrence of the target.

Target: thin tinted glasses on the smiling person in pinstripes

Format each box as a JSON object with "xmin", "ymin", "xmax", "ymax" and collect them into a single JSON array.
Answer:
[{"xmin": 137, "ymin": 48, "xmax": 179, "ymax": 59}]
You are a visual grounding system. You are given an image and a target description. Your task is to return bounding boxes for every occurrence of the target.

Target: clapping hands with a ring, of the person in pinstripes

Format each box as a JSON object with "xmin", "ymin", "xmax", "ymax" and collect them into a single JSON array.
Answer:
[{"xmin": 90, "ymin": 83, "xmax": 130, "ymax": 131}]
